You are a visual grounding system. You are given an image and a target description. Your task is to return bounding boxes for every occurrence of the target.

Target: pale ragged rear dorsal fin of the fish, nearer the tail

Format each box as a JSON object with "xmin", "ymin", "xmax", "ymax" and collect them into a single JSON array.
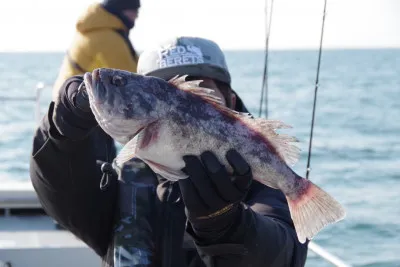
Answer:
[{"xmin": 250, "ymin": 118, "xmax": 300, "ymax": 166}]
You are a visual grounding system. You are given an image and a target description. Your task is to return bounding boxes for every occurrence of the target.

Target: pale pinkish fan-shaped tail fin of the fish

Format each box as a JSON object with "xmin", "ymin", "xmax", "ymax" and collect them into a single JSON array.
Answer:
[{"xmin": 286, "ymin": 178, "xmax": 346, "ymax": 243}]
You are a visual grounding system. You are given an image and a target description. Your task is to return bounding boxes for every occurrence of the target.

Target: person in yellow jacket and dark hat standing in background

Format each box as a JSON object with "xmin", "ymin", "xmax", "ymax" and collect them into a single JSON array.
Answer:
[{"xmin": 53, "ymin": 0, "xmax": 140, "ymax": 100}]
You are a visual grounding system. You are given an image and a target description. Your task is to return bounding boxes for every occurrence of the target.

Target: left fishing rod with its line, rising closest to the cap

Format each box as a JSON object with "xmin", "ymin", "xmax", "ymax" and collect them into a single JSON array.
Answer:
[{"xmin": 258, "ymin": 0, "xmax": 274, "ymax": 118}]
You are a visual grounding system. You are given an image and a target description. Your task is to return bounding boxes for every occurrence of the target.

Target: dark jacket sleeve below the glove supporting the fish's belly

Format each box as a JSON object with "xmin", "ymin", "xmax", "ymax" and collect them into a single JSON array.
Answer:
[{"xmin": 187, "ymin": 182, "xmax": 307, "ymax": 267}]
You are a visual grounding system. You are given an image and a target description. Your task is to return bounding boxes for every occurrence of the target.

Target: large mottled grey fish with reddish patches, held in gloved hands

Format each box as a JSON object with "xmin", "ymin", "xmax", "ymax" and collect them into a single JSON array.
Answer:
[{"xmin": 84, "ymin": 68, "xmax": 346, "ymax": 244}]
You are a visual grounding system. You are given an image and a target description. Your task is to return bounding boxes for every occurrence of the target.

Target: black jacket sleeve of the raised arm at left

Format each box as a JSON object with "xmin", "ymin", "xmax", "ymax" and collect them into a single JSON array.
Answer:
[{"xmin": 30, "ymin": 102, "xmax": 115, "ymax": 256}]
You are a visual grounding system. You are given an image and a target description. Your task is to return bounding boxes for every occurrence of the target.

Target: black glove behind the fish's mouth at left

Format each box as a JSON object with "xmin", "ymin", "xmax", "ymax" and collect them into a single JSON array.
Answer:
[{"xmin": 53, "ymin": 76, "xmax": 97, "ymax": 140}]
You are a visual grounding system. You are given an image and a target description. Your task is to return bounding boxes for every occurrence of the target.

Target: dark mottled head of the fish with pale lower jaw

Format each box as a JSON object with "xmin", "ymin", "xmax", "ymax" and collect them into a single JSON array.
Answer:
[{"xmin": 84, "ymin": 68, "xmax": 166, "ymax": 144}]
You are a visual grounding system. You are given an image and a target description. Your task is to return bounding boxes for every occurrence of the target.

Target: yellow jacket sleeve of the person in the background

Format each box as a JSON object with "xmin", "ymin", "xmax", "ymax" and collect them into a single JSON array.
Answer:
[{"xmin": 93, "ymin": 31, "xmax": 137, "ymax": 72}]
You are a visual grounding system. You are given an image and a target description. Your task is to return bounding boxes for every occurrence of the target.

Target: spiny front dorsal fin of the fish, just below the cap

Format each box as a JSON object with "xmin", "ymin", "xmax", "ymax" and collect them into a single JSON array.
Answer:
[{"xmin": 168, "ymin": 75, "xmax": 227, "ymax": 106}]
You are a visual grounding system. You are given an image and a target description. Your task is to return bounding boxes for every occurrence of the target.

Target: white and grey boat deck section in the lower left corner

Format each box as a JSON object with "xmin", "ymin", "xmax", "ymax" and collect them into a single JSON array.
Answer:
[{"xmin": 0, "ymin": 184, "xmax": 101, "ymax": 267}]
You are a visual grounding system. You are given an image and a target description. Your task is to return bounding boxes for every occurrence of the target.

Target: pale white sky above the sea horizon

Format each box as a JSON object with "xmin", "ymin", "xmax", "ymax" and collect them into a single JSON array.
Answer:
[{"xmin": 0, "ymin": 0, "xmax": 400, "ymax": 51}]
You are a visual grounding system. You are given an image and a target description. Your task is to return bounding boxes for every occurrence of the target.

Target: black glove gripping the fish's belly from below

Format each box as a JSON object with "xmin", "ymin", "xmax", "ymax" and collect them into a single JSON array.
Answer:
[{"xmin": 179, "ymin": 150, "xmax": 253, "ymax": 243}]
